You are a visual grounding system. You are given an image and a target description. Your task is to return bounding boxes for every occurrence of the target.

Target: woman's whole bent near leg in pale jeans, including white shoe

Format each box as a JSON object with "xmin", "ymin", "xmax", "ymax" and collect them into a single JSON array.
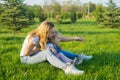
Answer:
[{"xmin": 21, "ymin": 49, "xmax": 83, "ymax": 74}]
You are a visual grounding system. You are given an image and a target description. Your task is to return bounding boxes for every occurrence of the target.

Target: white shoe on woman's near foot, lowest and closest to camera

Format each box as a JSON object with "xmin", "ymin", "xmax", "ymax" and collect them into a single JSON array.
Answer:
[{"xmin": 64, "ymin": 64, "xmax": 84, "ymax": 75}]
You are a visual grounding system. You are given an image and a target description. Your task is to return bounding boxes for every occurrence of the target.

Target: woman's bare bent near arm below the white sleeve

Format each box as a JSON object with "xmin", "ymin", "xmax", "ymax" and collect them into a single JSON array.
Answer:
[{"xmin": 24, "ymin": 40, "xmax": 40, "ymax": 56}]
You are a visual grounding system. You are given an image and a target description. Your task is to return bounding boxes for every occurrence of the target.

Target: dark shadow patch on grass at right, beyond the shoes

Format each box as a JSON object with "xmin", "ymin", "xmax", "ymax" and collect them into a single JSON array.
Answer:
[{"xmin": 78, "ymin": 52, "xmax": 120, "ymax": 74}]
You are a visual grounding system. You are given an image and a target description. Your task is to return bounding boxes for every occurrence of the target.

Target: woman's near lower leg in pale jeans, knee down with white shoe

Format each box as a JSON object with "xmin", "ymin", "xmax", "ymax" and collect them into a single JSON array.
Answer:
[{"xmin": 47, "ymin": 50, "xmax": 84, "ymax": 74}]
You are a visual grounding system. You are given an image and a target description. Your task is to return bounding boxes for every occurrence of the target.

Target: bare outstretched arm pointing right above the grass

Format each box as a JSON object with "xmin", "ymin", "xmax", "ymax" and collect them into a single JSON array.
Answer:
[{"xmin": 58, "ymin": 36, "xmax": 84, "ymax": 42}]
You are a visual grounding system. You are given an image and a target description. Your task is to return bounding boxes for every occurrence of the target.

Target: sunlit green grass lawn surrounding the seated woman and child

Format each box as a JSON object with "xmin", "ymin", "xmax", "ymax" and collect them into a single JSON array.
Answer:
[{"xmin": 0, "ymin": 19, "xmax": 120, "ymax": 80}]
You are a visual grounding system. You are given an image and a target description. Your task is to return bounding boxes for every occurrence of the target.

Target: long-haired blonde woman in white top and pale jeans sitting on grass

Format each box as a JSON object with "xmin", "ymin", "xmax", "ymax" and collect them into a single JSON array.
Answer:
[{"xmin": 20, "ymin": 21, "xmax": 84, "ymax": 74}]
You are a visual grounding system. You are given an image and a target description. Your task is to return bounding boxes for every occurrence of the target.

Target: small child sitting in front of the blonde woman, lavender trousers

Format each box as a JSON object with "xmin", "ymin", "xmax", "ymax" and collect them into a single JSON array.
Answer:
[{"xmin": 47, "ymin": 31, "xmax": 76, "ymax": 65}]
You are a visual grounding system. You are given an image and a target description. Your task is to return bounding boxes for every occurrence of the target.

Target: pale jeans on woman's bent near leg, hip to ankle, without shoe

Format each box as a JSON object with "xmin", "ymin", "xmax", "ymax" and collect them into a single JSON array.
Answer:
[{"xmin": 24, "ymin": 49, "xmax": 66, "ymax": 69}]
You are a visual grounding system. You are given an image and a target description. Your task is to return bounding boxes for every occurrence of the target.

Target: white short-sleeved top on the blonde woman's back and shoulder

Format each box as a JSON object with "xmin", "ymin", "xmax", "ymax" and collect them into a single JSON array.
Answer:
[{"xmin": 20, "ymin": 35, "xmax": 39, "ymax": 56}]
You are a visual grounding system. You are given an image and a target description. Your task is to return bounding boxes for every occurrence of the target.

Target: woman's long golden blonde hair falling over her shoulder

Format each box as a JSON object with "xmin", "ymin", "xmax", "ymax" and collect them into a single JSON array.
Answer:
[{"xmin": 29, "ymin": 21, "xmax": 54, "ymax": 50}]
